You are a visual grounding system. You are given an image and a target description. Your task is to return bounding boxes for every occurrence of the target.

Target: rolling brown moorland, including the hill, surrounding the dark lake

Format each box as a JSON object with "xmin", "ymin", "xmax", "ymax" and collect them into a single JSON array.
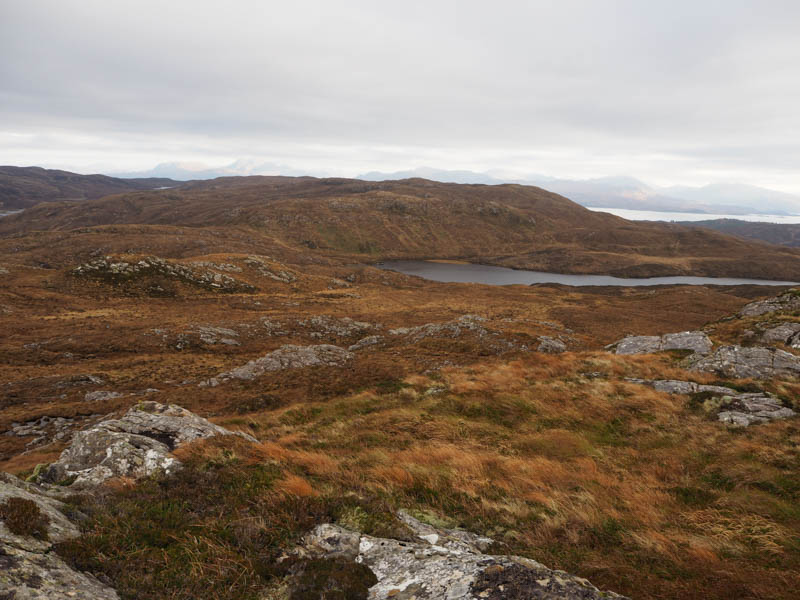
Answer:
[{"xmin": 0, "ymin": 177, "xmax": 800, "ymax": 599}]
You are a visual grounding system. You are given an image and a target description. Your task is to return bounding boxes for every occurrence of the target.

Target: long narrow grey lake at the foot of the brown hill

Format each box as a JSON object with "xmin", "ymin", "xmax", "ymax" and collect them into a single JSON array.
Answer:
[{"xmin": 377, "ymin": 260, "xmax": 796, "ymax": 287}]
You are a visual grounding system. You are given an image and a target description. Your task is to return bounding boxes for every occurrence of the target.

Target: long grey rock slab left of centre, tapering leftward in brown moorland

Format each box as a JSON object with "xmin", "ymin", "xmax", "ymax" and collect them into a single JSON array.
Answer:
[{"xmin": 199, "ymin": 344, "xmax": 353, "ymax": 387}]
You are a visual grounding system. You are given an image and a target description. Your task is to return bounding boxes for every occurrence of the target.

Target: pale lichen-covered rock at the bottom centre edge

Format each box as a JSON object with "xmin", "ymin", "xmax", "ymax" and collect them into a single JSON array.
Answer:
[{"xmin": 295, "ymin": 512, "xmax": 623, "ymax": 600}]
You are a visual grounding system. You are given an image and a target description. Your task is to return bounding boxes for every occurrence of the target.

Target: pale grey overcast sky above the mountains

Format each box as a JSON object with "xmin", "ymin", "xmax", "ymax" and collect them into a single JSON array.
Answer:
[{"xmin": 0, "ymin": 0, "xmax": 800, "ymax": 193}]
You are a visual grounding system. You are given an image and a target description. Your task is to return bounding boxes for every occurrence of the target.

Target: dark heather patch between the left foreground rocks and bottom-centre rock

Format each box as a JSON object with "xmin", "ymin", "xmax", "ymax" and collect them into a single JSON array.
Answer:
[{"xmin": 56, "ymin": 440, "xmax": 402, "ymax": 600}]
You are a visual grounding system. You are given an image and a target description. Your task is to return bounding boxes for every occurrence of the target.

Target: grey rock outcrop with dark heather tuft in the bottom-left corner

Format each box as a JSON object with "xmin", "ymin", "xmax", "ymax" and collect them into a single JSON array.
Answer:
[{"xmin": 0, "ymin": 473, "xmax": 118, "ymax": 600}]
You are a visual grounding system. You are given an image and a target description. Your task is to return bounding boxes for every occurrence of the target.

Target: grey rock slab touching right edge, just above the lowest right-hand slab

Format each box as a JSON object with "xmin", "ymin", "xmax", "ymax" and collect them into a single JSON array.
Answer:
[{"xmin": 689, "ymin": 346, "xmax": 800, "ymax": 379}]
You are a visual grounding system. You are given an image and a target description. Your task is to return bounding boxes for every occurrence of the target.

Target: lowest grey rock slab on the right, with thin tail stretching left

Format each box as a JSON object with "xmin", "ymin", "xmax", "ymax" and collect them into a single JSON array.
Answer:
[{"xmin": 628, "ymin": 379, "xmax": 797, "ymax": 427}]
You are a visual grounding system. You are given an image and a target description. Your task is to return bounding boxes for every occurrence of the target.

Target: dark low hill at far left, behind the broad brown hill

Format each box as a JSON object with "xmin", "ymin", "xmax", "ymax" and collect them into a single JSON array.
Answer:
[{"xmin": 0, "ymin": 166, "xmax": 182, "ymax": 210}]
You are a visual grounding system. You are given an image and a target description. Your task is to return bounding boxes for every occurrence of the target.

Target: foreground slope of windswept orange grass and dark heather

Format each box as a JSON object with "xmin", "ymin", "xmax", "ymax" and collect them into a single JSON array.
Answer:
[{"xmin": 54, "ymin": 355, "xmax": 800, "ymax": 599}]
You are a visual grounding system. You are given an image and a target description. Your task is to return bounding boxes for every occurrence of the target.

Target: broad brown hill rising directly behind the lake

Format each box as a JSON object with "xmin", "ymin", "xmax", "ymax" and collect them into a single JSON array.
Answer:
[{"xmin": 0, "ymin": 177, "xmax": 800, "ymax": 280}]
